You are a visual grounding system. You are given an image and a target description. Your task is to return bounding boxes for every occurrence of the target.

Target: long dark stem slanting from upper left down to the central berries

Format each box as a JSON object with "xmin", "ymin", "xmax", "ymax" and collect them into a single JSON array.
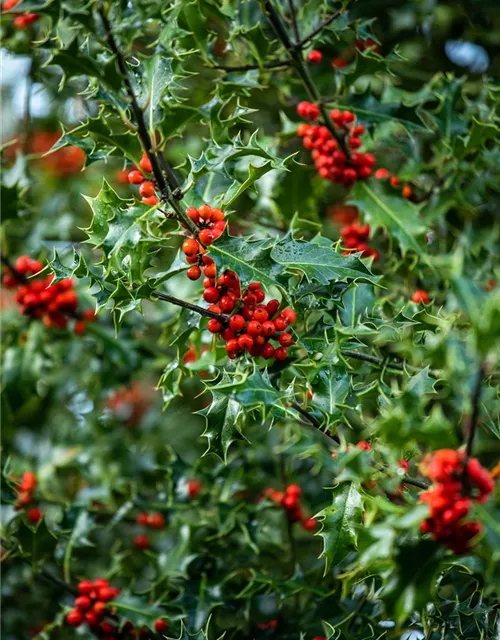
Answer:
[{"xmin": 99, "ymin": 8, "xmax": 198, "ymax": 237}]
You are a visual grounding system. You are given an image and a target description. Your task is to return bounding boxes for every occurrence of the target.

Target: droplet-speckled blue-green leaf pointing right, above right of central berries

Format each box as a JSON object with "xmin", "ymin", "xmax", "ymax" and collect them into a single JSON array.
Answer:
[{"xmin": 271, "ymin": 234, "xmax": 377, "ymax": 284}]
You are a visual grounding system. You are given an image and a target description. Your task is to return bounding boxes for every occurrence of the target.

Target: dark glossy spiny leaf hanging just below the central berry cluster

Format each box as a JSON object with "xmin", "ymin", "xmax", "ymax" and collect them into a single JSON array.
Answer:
[{"xmin": 198, "ymin": 393, "xmax": 244, "ymax": 462}]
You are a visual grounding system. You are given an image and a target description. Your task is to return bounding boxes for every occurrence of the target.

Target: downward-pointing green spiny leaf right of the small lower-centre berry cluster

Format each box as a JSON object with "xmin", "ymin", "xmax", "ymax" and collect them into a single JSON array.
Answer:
[{"xmin": 318, "ymin": 482, "xmax": 363, "ymax": 575}]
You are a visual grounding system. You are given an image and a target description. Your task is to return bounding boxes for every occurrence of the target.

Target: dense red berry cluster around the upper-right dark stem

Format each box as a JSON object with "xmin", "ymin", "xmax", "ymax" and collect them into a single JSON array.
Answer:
[{"xmin": 297, "ymin": 107, "xmax": 376, "ymax": 187}]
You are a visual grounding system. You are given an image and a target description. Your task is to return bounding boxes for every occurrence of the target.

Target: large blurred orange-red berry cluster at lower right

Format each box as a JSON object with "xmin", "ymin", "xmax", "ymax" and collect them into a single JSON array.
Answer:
[{"xmin": 420, "ymin": 449, "xmax": 494, "ymax": 554}]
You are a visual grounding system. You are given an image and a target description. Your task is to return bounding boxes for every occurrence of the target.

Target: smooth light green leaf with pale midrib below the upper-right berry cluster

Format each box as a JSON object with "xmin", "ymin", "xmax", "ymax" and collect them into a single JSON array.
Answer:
[{"xmin": 349, "ymin": 182, "xmax": 426, "ymax": 255}]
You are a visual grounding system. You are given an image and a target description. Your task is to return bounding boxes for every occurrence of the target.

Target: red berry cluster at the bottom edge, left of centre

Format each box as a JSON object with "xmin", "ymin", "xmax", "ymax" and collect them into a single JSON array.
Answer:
[{"xmin": 66, "ymin": 578, "xmax": 120, "ymax": 640}]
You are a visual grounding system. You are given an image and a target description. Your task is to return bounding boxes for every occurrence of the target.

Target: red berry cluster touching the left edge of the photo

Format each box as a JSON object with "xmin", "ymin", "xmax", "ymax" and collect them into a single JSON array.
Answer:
[{"xmin": 2, "ymin": 256, "xmax": 95, "ymax": 335}]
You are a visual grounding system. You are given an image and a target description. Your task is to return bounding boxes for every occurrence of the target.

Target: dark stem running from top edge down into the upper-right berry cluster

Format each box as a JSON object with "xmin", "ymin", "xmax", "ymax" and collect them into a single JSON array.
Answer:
[{"xmin": 261, "ymin": 0, "xmax": 351, "ymax": 158}]
